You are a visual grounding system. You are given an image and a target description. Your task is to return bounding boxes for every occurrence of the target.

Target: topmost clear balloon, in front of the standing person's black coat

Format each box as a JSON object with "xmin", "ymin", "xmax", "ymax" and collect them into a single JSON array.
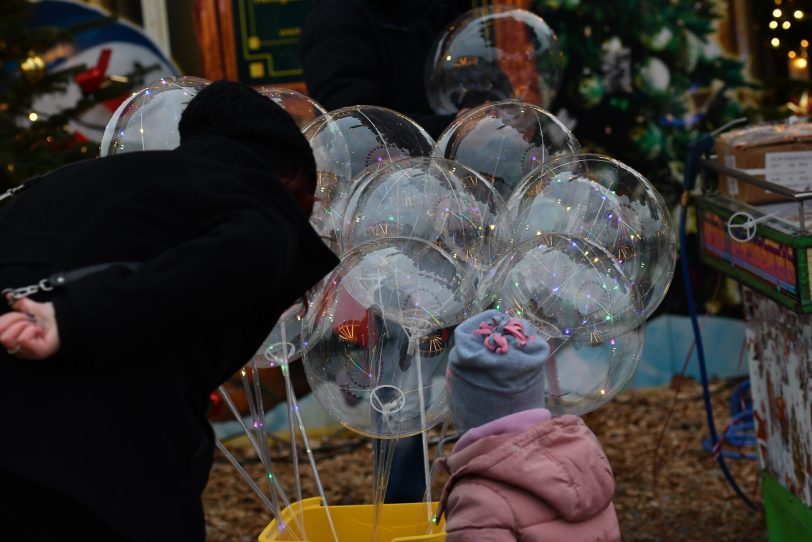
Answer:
[{"xmin": 426, "ymin": 6, "xmax": 563, "ymax": 114}]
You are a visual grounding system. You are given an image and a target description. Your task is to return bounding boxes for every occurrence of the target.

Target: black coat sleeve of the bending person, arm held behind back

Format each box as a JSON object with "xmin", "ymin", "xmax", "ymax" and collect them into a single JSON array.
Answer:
[{"xmin": 54, "ymin": 209, "xmax": 298, "ymax": 366}]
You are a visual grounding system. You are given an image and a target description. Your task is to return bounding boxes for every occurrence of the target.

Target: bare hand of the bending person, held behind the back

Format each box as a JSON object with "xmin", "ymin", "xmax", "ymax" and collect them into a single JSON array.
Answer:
[{"xmin": 0, "ymin": 298, "xmax": 59, "ymax": 360}]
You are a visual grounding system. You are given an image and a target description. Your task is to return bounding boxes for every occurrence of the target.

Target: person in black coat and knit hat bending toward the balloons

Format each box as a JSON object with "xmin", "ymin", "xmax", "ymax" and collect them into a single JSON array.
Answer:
[{"xmin": 0, "ymin": 81, "xmax": 338, "ymax": 542}]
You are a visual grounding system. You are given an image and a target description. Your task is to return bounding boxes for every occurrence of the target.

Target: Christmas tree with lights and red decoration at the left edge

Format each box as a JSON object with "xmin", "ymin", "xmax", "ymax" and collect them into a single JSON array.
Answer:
[{"xmin": 0, "ymin": 0, "xmax": 151, "ymax": 192}]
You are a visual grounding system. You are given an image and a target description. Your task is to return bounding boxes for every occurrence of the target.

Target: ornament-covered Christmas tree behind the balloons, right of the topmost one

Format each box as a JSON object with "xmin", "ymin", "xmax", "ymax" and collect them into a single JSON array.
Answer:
[{"xmin": 528, "ymin": 0, "xmax": 747, "ymax": 203}]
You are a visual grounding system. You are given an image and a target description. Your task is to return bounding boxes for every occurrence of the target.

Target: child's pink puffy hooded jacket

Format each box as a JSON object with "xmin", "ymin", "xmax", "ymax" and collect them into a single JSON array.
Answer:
[{"xmin": 438, "ymin": 410, "xmax": 620, "ymax": 542}]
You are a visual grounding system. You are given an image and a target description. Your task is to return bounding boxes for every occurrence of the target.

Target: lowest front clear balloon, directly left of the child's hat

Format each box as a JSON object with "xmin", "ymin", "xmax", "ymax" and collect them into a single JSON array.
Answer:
[{"xmin": 303, "ymin": 239, "xmax": 477, "ymax": 438}]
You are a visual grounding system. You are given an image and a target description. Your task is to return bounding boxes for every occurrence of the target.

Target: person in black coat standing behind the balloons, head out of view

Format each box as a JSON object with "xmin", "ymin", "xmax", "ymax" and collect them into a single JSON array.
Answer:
[{"xmin": 300, "ymin": 0, "xmax": 473, "ymax": 138}]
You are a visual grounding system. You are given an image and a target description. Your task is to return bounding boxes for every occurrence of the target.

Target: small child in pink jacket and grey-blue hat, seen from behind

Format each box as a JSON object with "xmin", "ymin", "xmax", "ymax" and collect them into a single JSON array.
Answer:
[{"xmin": 438, "ymin": 310, "xmax": 620, "ymax": 542}]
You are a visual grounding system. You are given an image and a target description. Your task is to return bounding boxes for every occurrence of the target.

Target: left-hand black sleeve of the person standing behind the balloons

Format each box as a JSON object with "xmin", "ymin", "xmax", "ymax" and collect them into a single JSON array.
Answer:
[{"xmin": 300, "ymin": 2, "xmax": 386, "ymax": 113}]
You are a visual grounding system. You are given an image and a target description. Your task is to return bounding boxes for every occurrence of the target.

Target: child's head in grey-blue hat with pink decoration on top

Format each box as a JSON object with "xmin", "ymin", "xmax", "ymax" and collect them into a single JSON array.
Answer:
[{"xmin": 447, "ymin": 310, "xmax": 550, "ymax": 432}]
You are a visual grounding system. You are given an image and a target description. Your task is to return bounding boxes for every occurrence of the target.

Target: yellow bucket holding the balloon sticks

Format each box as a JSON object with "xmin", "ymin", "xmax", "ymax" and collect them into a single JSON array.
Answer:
[{"xmin": 259, "ymin": 497, "xmax": 445, "ymax": 542}]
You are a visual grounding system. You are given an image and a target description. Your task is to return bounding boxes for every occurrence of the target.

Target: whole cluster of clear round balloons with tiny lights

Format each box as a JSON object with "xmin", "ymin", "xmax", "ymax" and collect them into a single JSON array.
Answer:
[{"xmin": 102, "ymin": 8, "xmax": 676, "ymax": 438}]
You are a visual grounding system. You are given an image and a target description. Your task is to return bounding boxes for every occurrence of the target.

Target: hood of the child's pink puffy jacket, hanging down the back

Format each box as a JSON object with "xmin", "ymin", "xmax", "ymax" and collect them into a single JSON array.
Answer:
[{"xmin": 441, "ymin": 415, "xmax": 615, "ymax": 522}]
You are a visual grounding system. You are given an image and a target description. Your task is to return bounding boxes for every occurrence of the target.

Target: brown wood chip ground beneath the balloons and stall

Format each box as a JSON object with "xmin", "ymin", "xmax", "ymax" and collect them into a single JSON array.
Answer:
[{"xmin": 203, "ymin": 380, "xmax": 767, "ymax": 542}]
